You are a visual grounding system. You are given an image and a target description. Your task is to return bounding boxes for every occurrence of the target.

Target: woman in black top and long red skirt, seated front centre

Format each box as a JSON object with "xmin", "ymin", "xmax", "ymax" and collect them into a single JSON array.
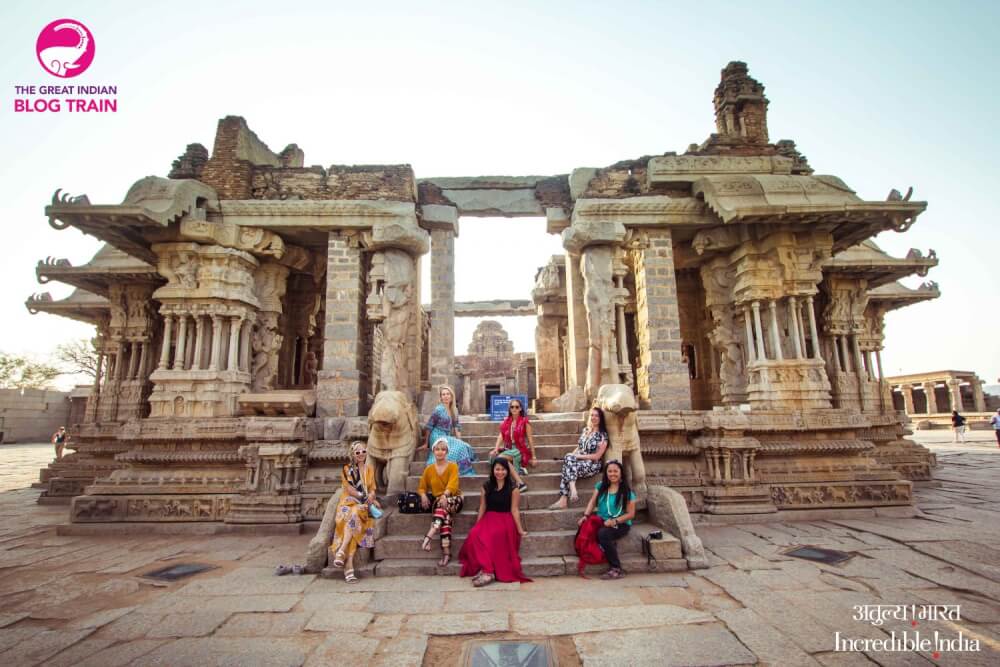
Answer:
[{"xmin": 458, "ymin": 458, "xmax": 531, "ymax": 587}]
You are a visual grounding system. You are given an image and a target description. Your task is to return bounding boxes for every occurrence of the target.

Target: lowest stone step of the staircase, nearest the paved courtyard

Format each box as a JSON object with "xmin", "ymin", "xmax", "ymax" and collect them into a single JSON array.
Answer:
[{"xmin": 375, "ymin": 554, "xmax": 687, "ymax": 576}]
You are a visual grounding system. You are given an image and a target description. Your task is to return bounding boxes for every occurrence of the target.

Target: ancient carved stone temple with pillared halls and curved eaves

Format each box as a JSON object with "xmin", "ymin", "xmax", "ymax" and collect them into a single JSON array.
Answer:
[{"xmin": 27, "ymin": 62, "xmax": 938, "ymax": 558}]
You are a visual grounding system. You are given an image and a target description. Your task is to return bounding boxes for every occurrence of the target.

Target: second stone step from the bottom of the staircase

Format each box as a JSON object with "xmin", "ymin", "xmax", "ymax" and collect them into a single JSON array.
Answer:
[{"xmin": 375, "ymin": 523, "xmax": 682, "ymax": 561}]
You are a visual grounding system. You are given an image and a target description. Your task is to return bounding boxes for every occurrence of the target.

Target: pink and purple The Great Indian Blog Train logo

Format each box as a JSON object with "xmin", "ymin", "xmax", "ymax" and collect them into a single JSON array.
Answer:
[{"xmin": 14, "ymin": 19, "xmax": 118, "ymax": 114}]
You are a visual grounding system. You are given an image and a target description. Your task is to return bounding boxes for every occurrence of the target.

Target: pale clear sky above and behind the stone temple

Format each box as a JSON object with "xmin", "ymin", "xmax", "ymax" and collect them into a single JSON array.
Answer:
[{"xmin": 0, "ymin": 1, "xmax": 1000, "ymax": 382}]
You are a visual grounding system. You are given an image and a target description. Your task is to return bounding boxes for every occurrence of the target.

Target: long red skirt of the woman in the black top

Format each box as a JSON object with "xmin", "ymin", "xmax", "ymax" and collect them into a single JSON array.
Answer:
[{"xmin": 458, "ymin": 512, "xmax": 531, "ymax": 581}]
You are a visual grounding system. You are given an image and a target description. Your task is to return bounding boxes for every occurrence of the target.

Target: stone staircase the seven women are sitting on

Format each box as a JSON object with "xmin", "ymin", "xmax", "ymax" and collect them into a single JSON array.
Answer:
[{"xmin": 366, "ymin": 417, "xmax": 687, "ymax": 577}]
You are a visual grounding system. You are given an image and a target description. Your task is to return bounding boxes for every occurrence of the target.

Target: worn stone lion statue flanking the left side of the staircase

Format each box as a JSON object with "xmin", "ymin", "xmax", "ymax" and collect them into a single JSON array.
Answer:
[{"xmin": 368, "ymin": 390, "xmax": 420, "ymax": 495}]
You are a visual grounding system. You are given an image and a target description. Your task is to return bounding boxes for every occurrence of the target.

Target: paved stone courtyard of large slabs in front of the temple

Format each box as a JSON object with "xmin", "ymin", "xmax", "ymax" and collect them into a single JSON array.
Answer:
[{"xmin": 0, "ymin": 431, "xmax": 1000, "ymax": 667}]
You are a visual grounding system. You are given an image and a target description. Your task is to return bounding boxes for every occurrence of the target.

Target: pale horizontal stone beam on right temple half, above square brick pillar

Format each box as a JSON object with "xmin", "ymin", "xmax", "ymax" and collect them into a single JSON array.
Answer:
[{"xmin": 573, "ymin": 195, "xmax": 718, "ymax": 227}]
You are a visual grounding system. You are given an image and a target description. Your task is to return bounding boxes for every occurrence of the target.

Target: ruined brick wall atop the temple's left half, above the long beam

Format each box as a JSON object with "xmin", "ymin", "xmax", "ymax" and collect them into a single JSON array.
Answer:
[{"xmin": 250, "ymin": 164, "xmax": 416, "ymax": 201}]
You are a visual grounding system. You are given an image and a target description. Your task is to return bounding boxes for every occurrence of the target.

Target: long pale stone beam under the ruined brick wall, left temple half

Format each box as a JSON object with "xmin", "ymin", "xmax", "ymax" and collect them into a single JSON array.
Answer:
[{"xmin": 219, "ymin": 199, "xmax": 417, "ymax": 232}]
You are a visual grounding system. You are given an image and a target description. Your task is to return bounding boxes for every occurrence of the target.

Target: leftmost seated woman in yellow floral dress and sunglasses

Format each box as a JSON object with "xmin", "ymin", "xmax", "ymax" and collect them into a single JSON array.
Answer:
[{"xmin": 330, "ymin": 441, "xmax": 382, "ymax": 584}]
